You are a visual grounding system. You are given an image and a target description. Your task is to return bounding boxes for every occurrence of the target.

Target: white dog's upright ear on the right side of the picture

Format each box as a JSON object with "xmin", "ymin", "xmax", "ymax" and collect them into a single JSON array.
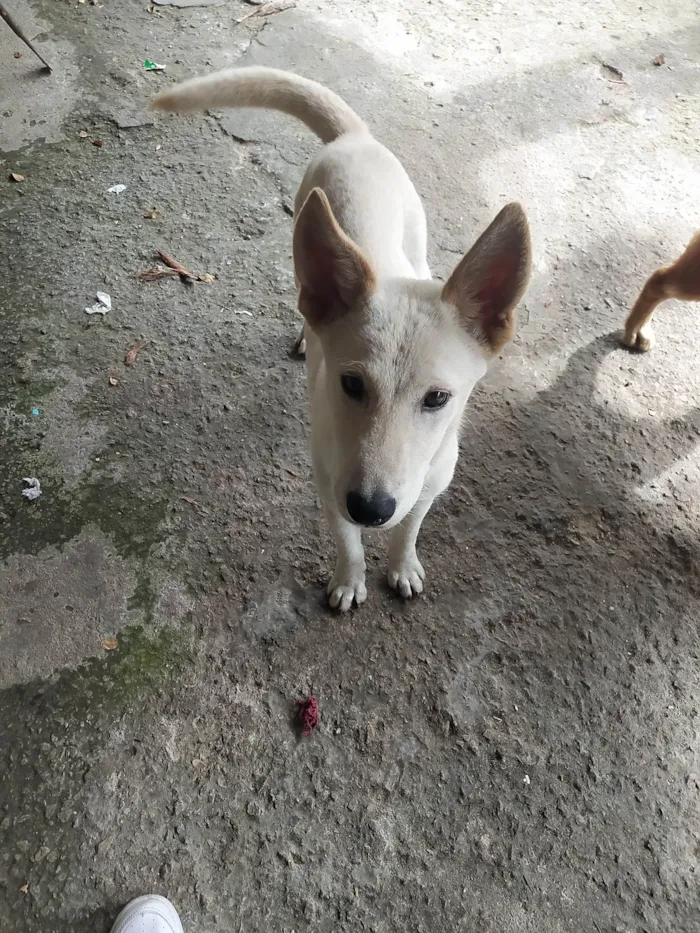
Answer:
[{"xmin": 442, "ymin": 204, "xmax": 531, "ymax": 355}]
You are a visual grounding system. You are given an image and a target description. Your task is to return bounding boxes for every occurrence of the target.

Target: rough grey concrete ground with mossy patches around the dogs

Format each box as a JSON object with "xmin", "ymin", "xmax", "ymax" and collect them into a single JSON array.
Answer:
[{"xmin": 0, "ymin": 0, "xmax": 700, "ymax": 933}]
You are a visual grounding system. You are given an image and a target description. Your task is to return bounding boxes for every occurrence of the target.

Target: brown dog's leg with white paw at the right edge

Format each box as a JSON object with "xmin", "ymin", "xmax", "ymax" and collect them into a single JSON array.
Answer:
[{"xmin": 622, "ymin": 233, "xmax": 700, "ymax": 352}]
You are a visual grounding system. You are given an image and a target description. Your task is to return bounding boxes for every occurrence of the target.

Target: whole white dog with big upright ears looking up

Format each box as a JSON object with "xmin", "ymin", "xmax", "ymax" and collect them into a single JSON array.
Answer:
[{"xmin": 153, "ymin": 68, "xmax": 530, "ymax": 612}]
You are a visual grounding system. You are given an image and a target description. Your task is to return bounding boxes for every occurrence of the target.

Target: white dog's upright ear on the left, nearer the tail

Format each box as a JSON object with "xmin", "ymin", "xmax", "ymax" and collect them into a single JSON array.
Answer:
[{"xmin": 293, "ymin": 188, "xmax": 376, "ymax": 327}]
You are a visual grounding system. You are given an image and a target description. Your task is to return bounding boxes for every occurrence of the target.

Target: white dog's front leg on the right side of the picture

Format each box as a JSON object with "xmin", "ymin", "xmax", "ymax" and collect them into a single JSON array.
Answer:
[{"xmin": 387, "ymin": 435, "xmax": 458, "ymax": 599}]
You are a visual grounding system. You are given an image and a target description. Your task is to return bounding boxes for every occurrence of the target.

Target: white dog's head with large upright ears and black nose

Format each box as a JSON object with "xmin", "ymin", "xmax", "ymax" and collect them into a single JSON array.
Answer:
[{"xmin": 294, "ymin": 188, "xmax": 530, "ymax": 528}]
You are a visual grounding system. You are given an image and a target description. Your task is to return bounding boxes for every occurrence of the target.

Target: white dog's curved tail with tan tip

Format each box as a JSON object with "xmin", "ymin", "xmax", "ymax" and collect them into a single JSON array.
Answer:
[{"xmin": 151, "ymin": 67, "xmax": 367, "ymax": 143}]
